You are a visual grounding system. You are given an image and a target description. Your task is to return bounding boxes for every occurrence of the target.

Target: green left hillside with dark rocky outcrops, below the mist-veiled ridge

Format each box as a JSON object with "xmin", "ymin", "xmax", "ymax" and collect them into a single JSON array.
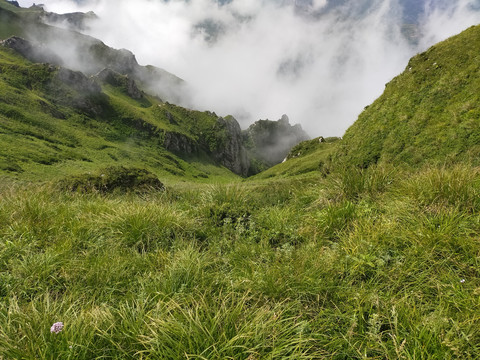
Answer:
[{"xmin": 0, "ymin": 39, "xmax": 247, "ymax": 180}]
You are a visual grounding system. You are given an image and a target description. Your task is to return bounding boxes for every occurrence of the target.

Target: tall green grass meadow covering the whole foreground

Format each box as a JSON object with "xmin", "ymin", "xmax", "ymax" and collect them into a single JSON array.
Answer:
[{"xmin": 0, "ymin": 165, "xmax": 480, "ymax": 359}]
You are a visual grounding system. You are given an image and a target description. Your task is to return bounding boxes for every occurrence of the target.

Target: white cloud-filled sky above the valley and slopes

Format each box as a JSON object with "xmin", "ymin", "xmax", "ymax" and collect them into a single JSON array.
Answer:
[{"xmin": 19, "ymin": 0, "xmax": 480, "ymax": 137}]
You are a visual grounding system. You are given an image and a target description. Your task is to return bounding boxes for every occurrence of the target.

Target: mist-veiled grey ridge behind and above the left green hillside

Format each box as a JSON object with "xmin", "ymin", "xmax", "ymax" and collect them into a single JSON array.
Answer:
[{"xmin": 0, "ymin": 0, "xmax": 189, "ymax": 104}]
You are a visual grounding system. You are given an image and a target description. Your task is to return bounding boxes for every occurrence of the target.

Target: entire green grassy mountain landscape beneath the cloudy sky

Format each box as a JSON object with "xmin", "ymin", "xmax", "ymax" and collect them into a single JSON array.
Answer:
[{"xmin": 0, "ymin": 0, "xmax": 480, "ymax": 360}]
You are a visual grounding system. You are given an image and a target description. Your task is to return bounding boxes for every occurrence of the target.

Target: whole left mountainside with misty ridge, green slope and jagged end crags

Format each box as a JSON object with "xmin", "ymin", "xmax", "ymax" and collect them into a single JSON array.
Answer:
[{"xmin": 0, "ymin": 1, "xmax": 310, "ymax": 179}]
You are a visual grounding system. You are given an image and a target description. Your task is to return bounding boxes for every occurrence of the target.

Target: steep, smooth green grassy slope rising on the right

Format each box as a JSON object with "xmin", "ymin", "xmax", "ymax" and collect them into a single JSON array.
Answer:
[{"xmin": 339, "ymin": 26, "xmax": 480, "ymax": 168}]
